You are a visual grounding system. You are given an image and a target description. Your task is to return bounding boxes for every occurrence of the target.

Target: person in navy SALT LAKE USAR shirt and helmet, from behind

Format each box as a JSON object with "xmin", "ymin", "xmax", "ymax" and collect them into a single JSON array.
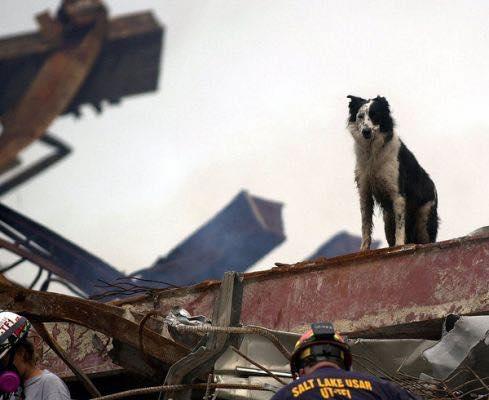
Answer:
[{"xmin": 272, "ymin": 323, "xmax": 417, "ymax": 400}]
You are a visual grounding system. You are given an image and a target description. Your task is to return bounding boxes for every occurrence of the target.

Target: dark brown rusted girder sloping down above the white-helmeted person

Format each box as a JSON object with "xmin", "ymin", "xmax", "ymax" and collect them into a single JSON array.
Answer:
[{"xmin": 0, "ymin": 281, "xmax": 188, "ymax": 364}]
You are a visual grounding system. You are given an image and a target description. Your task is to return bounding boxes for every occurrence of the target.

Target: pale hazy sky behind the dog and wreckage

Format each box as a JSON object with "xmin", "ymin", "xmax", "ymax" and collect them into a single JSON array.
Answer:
[{"xmin": 0, "ymin": 0, "xmax": 489, "ymax": 282}]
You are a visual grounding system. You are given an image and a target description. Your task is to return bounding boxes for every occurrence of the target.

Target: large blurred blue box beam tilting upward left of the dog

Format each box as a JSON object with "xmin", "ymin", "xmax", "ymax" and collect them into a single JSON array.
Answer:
[{"xmin": 135, "ymin": 191, "xmax": 285, "ymax": 286}]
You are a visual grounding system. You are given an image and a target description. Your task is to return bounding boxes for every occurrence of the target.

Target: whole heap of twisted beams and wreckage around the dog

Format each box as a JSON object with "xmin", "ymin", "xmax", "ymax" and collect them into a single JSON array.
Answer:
[{"xmin": 0, "ymin": 0, "xmax": 489, "ymax": 400}]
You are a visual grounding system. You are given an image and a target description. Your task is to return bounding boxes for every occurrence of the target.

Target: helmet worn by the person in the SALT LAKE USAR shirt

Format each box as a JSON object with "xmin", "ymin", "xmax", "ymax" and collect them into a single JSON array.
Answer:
[{"xmin": 290, "ymin": 322, "xmax": 352, "ymax": 374}]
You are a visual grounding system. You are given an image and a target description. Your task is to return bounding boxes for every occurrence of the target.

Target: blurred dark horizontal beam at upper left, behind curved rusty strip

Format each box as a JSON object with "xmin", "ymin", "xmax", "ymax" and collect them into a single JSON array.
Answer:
[{"xmin": 0, "ymin": 12, "xmax": 163, "ymax": 115}]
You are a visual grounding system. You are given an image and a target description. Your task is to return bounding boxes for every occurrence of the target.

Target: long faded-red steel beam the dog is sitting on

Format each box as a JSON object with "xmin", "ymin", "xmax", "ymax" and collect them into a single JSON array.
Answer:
[{"xmin": 117, "ymin": 235, "xmax": 489, "ymax": 338}]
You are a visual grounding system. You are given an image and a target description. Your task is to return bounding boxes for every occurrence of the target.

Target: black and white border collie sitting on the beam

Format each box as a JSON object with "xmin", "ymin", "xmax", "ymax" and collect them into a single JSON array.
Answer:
[{"xmin": 348, "ymin": 96, "xmax": 438, "ymax": 250}]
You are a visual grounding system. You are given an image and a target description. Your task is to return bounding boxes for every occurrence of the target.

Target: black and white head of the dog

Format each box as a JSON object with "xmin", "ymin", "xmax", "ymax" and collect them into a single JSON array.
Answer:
[{"xmin": 347, "ymin": 96, "xmax": 394, "ymax": 145}]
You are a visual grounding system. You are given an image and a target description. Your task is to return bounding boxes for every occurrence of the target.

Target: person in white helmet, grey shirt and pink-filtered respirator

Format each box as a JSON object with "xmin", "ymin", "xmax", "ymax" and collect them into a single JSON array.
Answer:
[{"xmin": 0, "ymin": 311, "xmax": 70, "ymax": 400}]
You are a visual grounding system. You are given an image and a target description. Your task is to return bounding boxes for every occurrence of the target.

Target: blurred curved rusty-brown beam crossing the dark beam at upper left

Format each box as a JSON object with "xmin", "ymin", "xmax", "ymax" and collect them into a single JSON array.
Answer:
[{"xmin": 0, "ymin": 5, "xmax": 107, "ymax": 168}]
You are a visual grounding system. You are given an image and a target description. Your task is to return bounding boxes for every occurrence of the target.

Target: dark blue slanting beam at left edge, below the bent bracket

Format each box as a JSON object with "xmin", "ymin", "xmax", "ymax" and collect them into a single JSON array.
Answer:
[{"xmin": 0, "ymin": 204, "xmax": 123, "ymax": 295}]
